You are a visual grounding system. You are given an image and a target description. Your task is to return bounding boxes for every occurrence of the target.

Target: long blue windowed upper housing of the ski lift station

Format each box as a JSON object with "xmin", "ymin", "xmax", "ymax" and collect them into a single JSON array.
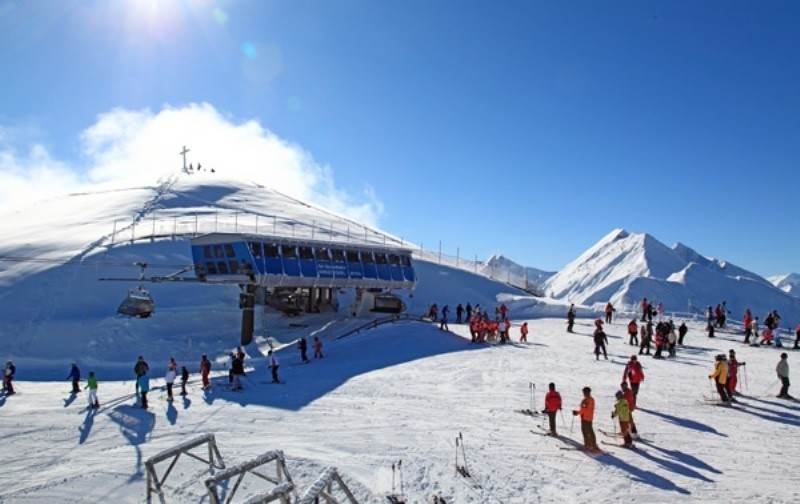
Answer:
[{"xmin": 192, "ymin": 233, "xmax": 417, "ymax": 289}]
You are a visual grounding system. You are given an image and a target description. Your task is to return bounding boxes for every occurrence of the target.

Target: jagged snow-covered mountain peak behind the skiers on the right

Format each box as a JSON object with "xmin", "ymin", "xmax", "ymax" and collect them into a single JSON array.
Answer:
[{"xmin": 544, "ymin": 229, "xmax": 800, "ymax": 320}]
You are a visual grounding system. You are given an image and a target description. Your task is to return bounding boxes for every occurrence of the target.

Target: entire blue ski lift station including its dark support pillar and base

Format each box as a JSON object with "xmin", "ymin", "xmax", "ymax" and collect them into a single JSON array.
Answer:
[{"xmin": 191, "ymin": 233, "xmax": 417, "ymax": 344}]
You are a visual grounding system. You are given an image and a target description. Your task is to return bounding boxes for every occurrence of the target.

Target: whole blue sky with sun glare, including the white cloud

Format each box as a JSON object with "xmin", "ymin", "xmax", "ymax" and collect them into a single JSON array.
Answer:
[{"xmin": 0, "ymin": 0, "xmax": 800, "ymax": 275}]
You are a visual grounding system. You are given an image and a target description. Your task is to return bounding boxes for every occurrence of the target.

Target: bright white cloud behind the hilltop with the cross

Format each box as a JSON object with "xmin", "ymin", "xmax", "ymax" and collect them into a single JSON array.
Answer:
[{"xmin": 0, "ymin": 103, "xmax": 383, "ymax": 225}]
